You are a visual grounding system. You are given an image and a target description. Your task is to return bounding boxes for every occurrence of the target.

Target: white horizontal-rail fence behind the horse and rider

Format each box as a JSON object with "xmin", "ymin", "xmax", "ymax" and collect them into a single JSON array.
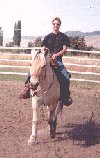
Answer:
[{"xmin": 0, "ymin": 47, "xmax": 100, "ymax": 83}]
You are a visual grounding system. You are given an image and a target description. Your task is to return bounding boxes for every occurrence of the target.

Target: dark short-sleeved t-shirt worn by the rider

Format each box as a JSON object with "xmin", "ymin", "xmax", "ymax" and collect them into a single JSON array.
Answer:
[{"xmin": 42, "ymin": 32, "xmax": 70, "ymax": 61}]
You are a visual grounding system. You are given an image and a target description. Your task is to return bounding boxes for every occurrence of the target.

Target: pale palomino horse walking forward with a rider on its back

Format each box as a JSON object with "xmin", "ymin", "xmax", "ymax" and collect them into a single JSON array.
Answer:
[{"xmin": 28, "ymin": 50, "xmax": 61, "ymax": 144}]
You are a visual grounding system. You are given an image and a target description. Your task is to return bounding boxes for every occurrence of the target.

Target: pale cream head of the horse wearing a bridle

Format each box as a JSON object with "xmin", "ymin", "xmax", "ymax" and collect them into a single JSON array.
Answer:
[{"xmin": 30, "ymin": 49, "xmax": 50, "ymax": 90}]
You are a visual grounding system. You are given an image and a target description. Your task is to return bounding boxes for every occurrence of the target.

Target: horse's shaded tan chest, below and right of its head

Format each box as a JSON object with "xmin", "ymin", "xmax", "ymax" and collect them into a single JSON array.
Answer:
[{"xmin": 38, "ymin": 67, "xmax": 60, "ymax": 103}]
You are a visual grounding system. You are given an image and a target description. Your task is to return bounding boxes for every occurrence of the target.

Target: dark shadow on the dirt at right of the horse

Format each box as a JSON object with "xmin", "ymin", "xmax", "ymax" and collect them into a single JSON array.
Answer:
[{"xmin": 58, "ymin": 119, "xmax": 100, "ymax": 147}]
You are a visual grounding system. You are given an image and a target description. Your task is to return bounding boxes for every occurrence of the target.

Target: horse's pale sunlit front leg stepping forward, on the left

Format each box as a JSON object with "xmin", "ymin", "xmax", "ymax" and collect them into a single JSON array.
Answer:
[{"xmin": 28, "ymin": 97, "xmax": 39, "ymax": 145}]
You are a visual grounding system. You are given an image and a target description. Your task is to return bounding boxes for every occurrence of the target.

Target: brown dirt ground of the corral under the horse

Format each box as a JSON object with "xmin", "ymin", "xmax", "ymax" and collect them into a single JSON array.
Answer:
[{"xmin": 0, "ymin": 81, "xmax": 100, "ymax": 158}]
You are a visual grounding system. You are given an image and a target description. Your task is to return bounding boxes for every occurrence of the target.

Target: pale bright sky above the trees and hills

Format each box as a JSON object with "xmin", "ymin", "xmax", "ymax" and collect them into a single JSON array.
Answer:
[{"xmin": 0, "ymin": 0, "xmax": 100, "ymax": 38}]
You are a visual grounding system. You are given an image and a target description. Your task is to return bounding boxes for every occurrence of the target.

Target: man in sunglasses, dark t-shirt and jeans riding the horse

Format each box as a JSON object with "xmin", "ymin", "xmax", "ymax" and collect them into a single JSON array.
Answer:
[{"xmin": 20, "ymin": 17, "xmax": 73, "ymax": 106}]
